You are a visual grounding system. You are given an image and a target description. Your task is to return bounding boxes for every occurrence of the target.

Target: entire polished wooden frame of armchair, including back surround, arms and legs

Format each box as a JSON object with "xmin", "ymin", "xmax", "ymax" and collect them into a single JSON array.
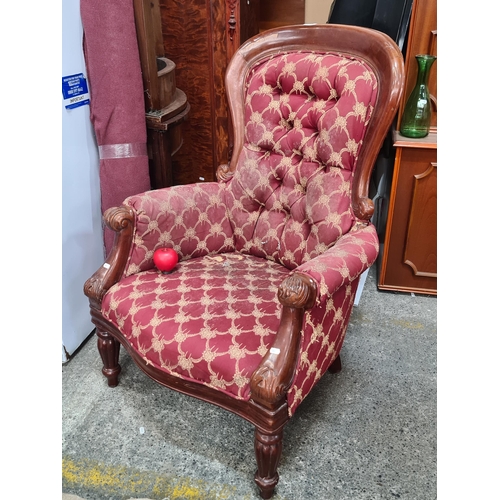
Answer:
[{"xmin": 84, "ymin": 25, "xmax": 403, "ymax": 499}]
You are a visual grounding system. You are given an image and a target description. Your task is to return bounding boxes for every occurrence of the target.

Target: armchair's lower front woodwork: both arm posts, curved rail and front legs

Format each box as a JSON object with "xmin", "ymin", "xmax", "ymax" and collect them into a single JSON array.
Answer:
[{"xmin": 84, "ymin": 206, "xmax": 318, "ymax": 498}]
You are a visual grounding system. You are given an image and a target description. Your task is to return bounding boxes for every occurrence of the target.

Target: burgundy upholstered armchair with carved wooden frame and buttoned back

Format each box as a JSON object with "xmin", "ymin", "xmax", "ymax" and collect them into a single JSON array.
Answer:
[{"xmin": 85, "ymin": 25, "xmax": 403, "ymax": 498}]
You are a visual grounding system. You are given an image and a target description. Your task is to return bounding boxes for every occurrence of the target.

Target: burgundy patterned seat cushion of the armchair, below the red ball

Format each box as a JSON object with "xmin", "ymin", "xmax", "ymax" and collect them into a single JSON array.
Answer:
[{"xmin": 102, "ymin": 253, "xmax": 289, "ymax": 400}]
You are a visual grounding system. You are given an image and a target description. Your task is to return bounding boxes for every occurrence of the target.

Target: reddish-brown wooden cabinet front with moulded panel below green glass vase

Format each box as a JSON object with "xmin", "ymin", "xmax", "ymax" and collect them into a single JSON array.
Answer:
[{"xmin": 379, "ymin": 148, "xmax": 437, "ymax": 294}]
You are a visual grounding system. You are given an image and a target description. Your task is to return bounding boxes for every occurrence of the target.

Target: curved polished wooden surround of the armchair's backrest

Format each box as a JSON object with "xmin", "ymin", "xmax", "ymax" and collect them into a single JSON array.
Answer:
[{"xmin": 223, "ymin": 24, "xmax": 404, "ymax": 221}]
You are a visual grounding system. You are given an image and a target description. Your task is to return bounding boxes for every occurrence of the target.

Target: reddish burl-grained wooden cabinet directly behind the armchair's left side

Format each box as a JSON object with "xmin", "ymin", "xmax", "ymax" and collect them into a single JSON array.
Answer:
[{"xmin": 160, "ymin": 0, "xmax": 260, "ymax": 184}]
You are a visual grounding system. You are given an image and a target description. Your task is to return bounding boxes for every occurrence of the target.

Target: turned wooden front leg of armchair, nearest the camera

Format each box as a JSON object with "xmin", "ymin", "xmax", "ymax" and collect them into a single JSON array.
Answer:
[{"xmin": 255, "ymin": 428, "xmax": 283, "ymax": 499}]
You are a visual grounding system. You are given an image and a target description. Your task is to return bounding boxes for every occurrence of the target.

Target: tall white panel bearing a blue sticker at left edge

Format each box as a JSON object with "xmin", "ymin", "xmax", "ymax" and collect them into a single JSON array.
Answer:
[{"xmin": 60, "ymin": 0, "xmax": 104, "ymax": 362}]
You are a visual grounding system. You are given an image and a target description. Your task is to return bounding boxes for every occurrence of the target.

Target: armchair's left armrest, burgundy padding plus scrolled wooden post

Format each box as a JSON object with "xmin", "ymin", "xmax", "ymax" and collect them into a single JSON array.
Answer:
[{"xmin": 84, "ymin": 182, "xmax": 234, "ymax": 304}]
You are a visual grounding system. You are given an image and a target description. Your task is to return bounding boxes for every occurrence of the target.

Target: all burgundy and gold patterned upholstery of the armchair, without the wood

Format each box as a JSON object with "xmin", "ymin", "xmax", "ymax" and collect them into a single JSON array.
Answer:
[{"xmin": 102, "ymin": 51, "xmax": 378, "ymax": 415}]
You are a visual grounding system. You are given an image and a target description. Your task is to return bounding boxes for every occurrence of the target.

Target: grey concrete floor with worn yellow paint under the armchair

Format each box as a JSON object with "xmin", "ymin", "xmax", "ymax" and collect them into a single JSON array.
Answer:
[{"xmin": 62, "ymin": 268, "xmax": 437, "ymax": 500}]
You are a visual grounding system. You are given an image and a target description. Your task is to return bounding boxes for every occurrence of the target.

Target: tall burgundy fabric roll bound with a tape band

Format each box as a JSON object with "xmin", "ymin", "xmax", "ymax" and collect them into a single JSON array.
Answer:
[{"xmin": 80, "ymin": 0, "xmax": 151, "ymax": 254}]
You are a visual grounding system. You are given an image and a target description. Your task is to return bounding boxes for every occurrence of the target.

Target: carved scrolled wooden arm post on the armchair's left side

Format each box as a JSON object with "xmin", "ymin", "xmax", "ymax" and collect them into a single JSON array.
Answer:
[{"xmin": 83, "ymin": 206, "xmax": 135, "ymax": 307}]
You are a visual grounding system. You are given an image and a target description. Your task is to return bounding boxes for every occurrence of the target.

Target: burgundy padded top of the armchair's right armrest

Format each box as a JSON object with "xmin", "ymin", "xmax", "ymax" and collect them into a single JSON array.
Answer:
[{"xmin": 296, "ymin": 223, "xmax": 379, "ymax": 302}]
